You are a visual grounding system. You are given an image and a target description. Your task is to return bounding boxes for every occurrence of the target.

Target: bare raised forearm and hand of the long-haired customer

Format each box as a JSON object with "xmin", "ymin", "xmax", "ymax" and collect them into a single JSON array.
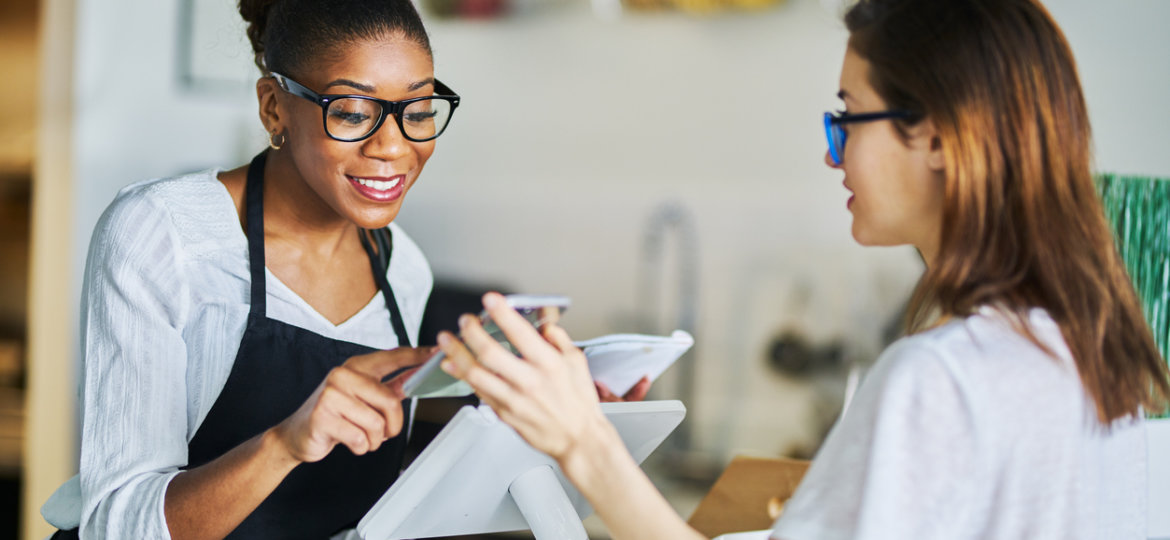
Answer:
[{"xmin": 439, "ymin": 292, "xmax": 702, "ymax": 540}]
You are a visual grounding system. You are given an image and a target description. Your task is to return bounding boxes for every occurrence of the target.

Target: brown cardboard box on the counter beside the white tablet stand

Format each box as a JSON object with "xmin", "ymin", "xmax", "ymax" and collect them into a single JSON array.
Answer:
[{"xmin": 687, "ymin": 456, "xmax": 810, "ymax": 538}]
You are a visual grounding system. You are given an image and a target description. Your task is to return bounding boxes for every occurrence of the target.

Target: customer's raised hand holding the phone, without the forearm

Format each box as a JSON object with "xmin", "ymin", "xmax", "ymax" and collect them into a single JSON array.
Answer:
[{"xmin": 439, "ymin": 292, "xmax": 608, "ymax": 462}]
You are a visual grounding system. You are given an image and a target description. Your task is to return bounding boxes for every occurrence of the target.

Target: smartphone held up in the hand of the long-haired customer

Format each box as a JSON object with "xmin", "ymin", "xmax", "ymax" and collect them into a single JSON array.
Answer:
[{"xmin": 402, "ymin": 295, "xmax": 570, "ymax": 397}]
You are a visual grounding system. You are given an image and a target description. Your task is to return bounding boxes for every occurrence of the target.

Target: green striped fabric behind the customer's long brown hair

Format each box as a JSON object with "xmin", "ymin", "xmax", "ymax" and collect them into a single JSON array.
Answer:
[{"xmin": 1097, "ymin": 174, "xmax": 1170, "ymax": 417}]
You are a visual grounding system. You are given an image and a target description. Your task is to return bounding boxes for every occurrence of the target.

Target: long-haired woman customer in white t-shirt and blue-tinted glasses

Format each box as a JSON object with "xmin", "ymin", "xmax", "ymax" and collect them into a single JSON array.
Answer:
[{"xmin": 440, "ymin": 0, "xmax": 1170, "ymax": 540}]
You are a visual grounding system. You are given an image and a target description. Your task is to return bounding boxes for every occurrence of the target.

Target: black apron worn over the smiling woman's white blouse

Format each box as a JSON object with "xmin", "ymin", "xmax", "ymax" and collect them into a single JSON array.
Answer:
[{"xmin": 54, "ymin": 153, "xmax": 411, "ymax": 540}]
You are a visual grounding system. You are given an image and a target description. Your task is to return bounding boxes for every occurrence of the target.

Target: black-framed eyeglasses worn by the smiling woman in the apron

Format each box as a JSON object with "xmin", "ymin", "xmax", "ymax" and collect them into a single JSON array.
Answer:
[{"xmin": 273, "ymin": 72, "xmax": 459, "ymax": 143}]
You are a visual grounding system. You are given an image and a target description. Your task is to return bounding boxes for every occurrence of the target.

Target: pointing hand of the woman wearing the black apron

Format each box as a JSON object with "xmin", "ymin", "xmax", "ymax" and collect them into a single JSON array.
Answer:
[{"xmin": 273, "ymin": 347, "xmax": 434, "ymax": 463}]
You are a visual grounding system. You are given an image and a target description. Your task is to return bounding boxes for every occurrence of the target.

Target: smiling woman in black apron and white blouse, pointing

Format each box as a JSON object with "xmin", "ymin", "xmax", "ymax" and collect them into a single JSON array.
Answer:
[{"xmin": 43, "ymin": 0, "xmax": 459, "ymax": 539}]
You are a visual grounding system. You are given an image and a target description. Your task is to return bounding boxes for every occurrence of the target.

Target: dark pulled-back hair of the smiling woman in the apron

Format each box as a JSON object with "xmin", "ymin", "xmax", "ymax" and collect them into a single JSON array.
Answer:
[{"xmin": 239, "ymin": 0, "xmax": 432, "ymax": 75}]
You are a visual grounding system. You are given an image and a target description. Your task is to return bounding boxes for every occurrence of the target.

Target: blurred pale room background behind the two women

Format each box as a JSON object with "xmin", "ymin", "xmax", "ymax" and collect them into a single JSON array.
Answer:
[{"xmin": 0, "ymin": 0, "xmax": 1170, "ymax": 539}]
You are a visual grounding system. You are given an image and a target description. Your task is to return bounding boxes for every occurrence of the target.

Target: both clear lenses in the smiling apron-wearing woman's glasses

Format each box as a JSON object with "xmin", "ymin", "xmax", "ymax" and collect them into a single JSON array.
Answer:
[{"xmin": 325, "ymin": 98, "xmax": 452, "ymax": 140}]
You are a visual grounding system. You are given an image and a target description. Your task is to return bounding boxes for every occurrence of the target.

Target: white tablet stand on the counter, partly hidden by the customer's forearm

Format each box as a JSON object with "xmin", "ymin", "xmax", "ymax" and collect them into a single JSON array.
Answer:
[{"xmin": 357, "ymin": 401, "xmax": 686, "ymax": 540}]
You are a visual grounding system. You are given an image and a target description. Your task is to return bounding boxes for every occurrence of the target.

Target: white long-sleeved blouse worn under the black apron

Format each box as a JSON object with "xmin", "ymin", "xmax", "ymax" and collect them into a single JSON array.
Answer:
[{"xmin": 41, "ymin": 169, "xmax": 433, "ymax": 539}]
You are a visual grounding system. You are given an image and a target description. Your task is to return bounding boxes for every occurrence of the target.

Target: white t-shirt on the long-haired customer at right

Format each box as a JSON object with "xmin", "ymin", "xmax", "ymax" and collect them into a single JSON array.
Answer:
[{"xmin": 771, "ymin": 307, "xmax": 1147, "ymax": 540}]
